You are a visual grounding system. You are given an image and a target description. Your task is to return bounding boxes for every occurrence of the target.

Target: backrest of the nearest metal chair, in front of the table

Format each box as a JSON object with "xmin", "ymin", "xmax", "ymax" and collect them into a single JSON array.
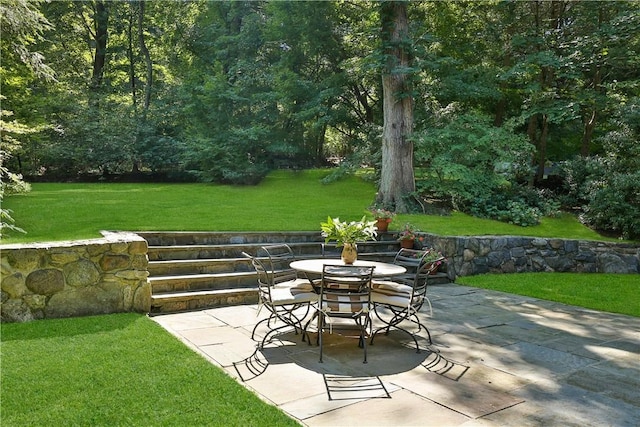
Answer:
[{"xmin": 320, "ymin": 265, "xmax": 373, "ymax": 317}]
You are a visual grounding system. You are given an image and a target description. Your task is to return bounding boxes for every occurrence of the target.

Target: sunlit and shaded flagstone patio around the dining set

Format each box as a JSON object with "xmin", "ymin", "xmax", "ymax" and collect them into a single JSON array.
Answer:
[{"xmin": 153, "ymin": 284, "xmax": 640, "ymax": 427}]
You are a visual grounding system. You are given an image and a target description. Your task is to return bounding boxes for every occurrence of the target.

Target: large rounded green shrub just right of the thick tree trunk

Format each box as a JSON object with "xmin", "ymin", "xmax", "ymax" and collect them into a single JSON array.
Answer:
[{"xmin": 416, "ymin": 108, "xmax": 551, "ymax": 226}]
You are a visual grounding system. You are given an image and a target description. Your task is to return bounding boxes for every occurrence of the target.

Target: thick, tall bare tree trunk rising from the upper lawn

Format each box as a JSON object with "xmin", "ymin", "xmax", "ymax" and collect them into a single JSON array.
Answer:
[{"xmin": 377, "ymin": 2, "xmax": 415, "ymax": 213}]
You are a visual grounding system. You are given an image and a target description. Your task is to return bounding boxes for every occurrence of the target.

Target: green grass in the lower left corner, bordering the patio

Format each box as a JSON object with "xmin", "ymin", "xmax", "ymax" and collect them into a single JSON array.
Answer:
[{"xmin": 0, "ymin": 314, "xmax": 297, "ymax": 426}]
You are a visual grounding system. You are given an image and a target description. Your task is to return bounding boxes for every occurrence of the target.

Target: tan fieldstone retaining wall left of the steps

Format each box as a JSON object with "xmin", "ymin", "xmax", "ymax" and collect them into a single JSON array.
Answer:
[{"xmin": 0, "ymin": 232, "xmax": 151, "ymax": 322}]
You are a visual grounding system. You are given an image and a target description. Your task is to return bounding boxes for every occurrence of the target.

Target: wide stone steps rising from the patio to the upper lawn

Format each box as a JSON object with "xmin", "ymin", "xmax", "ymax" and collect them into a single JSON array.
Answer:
[{"xmin": 137, "ymin": 232, "xmax": 448, "ymax": 314}]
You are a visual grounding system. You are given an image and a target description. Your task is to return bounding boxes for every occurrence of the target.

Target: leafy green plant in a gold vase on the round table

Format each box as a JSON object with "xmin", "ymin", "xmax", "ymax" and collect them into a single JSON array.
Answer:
[{"xmin": 320, "ymin": 216, "xmax": 377, "ymax": 264}]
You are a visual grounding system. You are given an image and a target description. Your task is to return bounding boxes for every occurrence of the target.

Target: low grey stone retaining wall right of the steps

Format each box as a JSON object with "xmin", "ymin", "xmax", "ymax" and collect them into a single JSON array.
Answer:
[{"xmin": 423, "ymin": 234, "xmax": 640, "ymax": 280}]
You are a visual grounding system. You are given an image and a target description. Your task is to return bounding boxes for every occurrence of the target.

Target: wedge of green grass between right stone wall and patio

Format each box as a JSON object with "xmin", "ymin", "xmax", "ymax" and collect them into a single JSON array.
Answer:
[{"xmin": 456, "ymin": 273, "xmax": 640, "ymax": 317}]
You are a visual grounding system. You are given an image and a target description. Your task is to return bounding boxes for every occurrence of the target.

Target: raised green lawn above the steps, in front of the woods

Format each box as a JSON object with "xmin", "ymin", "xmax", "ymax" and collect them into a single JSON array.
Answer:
[{"xmin": 3, "ymin": 170, "xmax": 611, "ymax": 243}]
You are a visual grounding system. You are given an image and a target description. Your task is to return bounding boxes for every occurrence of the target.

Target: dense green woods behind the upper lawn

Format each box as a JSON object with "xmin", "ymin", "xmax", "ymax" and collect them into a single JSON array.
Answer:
[{"xmin": 0, "ymin": 0, "xmax": 640, "ymax": 238}]
